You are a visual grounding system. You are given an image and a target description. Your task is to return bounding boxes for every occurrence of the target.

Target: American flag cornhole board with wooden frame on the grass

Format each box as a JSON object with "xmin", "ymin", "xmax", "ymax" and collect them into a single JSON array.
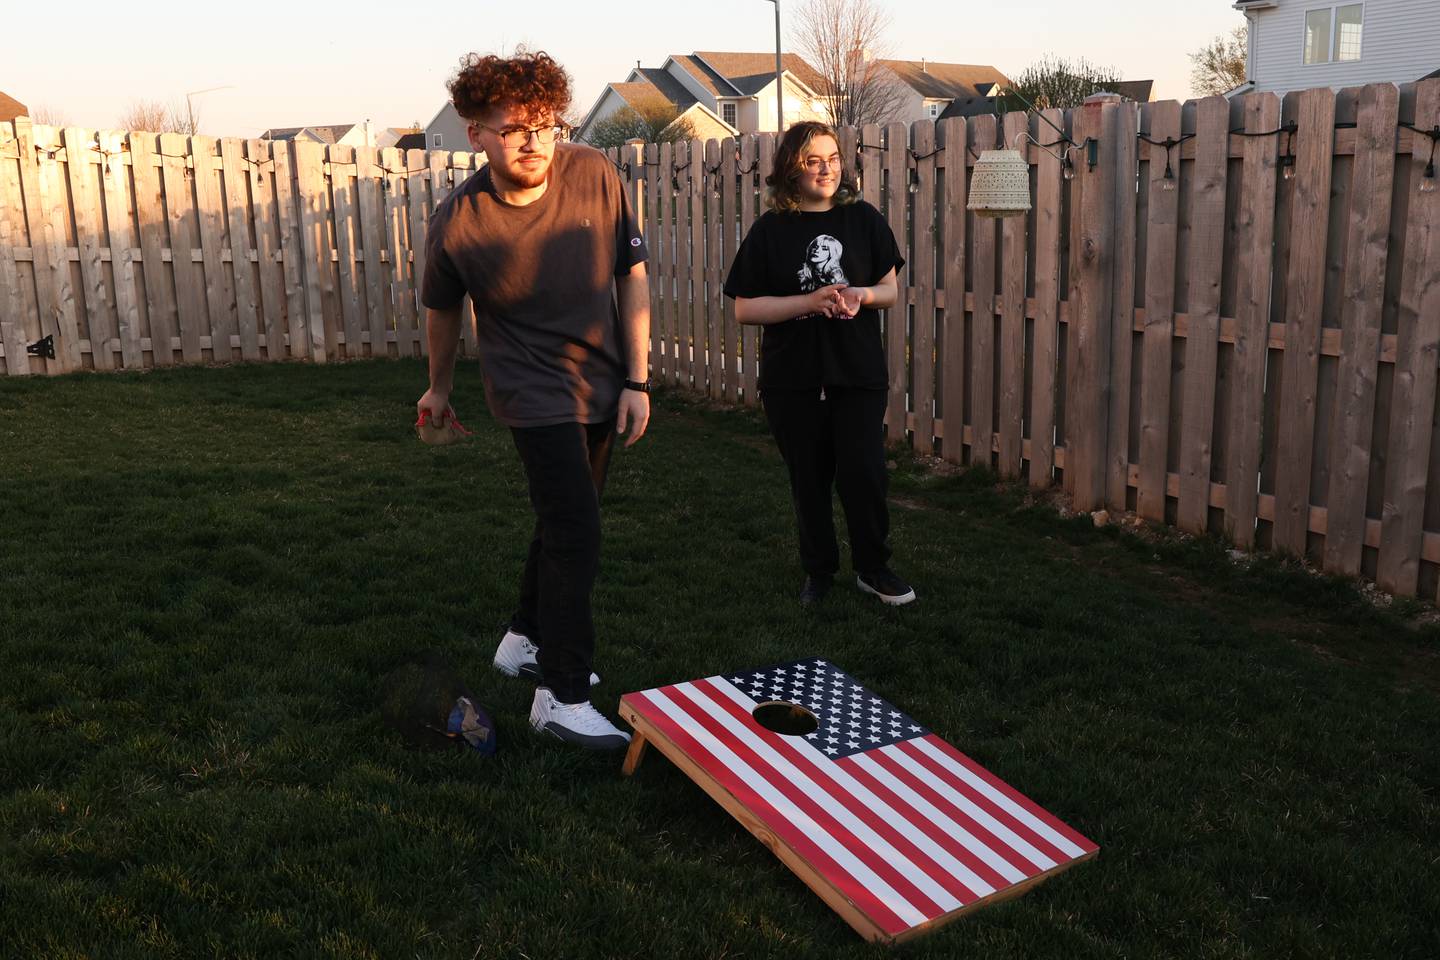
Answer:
[{"xmin": 619, "ymin": 658, "xmax": 1099, "ymax": 943}]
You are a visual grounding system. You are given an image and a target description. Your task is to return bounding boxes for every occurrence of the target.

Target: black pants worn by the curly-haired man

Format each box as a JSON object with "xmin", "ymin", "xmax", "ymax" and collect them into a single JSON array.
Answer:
[{"xmin": 510, "ymin": 420, "xmax": 615, "ymax": 704}]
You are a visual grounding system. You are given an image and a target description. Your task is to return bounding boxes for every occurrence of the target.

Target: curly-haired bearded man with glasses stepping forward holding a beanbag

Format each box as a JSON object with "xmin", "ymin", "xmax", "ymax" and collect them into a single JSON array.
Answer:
[{"xmin": 416, "ymin": 49, "xmax": 649, "ymax": 750}]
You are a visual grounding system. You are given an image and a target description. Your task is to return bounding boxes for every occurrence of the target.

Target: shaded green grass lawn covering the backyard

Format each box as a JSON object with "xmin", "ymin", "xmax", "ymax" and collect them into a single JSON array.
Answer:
[{"xmin": 0, "ymin": 361, "xmax": 1440, "ymax": 960}]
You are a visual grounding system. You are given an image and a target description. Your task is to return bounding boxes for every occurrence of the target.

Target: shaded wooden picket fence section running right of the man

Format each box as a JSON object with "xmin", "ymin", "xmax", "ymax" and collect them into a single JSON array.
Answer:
[{"xmin": 601, "ymin": 81, "xmax": 1440, "ymax": 597}]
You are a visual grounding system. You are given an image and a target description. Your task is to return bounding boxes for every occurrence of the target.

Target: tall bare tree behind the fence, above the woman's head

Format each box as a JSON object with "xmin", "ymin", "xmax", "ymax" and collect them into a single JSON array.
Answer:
[{"xmin": 791, "ymin": 0, "xmax": 909, "ymax": 127}]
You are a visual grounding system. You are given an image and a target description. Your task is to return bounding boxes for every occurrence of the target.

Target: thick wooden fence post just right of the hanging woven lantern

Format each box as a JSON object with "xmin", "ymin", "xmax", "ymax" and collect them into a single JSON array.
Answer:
[{"xmin": 1066, "ymin": 94, "xmax": 1122, "ymax": 511}]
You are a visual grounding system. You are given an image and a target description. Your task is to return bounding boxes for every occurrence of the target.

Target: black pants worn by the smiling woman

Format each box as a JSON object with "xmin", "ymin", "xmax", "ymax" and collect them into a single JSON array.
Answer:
[{"xmin": 760, "ymin": 387, "xmax": 890, "ymax": 576}]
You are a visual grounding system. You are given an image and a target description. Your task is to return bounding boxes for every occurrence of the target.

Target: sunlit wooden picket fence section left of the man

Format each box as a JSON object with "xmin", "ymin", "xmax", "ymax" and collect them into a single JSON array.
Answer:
[{"xmin": 0, "ymin": 118, "xmax": 474, "ymax": 374}]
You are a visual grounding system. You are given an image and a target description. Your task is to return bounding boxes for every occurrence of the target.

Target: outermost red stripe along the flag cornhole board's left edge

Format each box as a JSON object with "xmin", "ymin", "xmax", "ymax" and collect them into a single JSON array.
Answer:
[{"xmin": 631, "ymin": 687, "xmax": 910, "ymax": 934}]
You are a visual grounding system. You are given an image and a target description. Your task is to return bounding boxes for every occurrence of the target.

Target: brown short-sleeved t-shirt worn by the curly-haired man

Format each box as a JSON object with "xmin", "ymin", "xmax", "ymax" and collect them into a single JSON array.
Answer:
[{"xmin": 420, "ymin": 142, "xmax": 647, "ymax": 426}]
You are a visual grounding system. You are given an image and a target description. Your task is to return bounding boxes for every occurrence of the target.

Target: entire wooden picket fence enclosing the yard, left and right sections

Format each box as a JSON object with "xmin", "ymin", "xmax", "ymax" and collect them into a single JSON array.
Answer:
[{"xmin": 0, "ymin": 81, "xmax": 1440, "ymax": 597}]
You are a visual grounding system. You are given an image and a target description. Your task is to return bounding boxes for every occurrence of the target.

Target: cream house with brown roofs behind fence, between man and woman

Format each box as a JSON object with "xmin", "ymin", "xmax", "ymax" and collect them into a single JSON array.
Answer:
[{"xmin": 576, "ymin": 50, "xmax": 824, "ymax": 140}]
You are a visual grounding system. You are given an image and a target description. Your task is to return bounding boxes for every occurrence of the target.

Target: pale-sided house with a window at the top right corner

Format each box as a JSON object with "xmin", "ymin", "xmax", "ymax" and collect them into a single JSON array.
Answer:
[{"xmin": 1227, "ymin": 0, "xmax": 1440, "ymax": 96}]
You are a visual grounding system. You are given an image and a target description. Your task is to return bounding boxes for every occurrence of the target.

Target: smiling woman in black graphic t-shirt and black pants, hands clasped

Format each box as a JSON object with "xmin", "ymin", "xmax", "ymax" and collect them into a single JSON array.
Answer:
[{"xmin": 724, "ymin": 122, "xmax": 914, "ymax": 606}]
